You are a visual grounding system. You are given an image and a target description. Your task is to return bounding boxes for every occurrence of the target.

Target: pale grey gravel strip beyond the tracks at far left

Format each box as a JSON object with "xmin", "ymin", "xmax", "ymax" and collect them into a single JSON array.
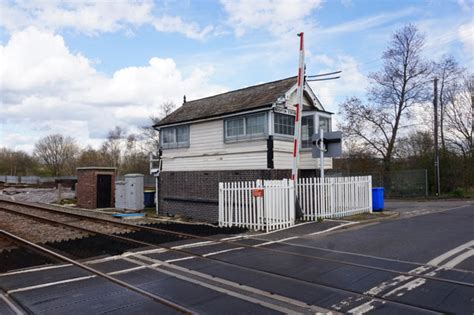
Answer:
[{"xmin": 0, "ymin": 187, "xmax": 76, "ymax": 203}]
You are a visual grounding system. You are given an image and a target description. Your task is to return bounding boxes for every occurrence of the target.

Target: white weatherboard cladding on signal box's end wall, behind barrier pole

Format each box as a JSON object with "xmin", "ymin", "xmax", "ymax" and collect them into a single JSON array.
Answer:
[{"xmin": 273, "ymin": 140, "xmax": 332, "ymax": 170}]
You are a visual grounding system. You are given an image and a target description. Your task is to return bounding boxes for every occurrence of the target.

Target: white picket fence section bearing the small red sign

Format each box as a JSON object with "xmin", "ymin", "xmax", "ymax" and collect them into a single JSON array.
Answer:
[{"xmin": 219, "ymin": 179, "xmax": 295, "ymax": 232}]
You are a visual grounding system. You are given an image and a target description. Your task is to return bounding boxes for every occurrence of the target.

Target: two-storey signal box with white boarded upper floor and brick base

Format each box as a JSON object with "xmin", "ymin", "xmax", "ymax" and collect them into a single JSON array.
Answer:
[{"xmin": 154, "ymin": 77, "xmax": 332, "ymax": 222}]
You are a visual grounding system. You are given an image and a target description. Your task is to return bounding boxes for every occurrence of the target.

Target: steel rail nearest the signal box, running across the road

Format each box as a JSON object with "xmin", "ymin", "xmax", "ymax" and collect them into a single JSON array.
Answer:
[{"xmin": 0, "ymin": 199, "xmax": 474, "ymax": 287}]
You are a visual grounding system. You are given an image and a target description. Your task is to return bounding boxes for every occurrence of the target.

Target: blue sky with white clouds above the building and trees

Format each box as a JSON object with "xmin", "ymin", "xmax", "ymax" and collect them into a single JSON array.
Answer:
[{"xmin": 0, "ymin": 0, "xmax": 474, "ymax": 152}]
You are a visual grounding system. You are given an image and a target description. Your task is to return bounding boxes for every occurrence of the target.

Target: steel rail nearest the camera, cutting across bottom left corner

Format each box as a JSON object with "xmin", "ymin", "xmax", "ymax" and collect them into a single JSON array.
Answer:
[{"xmin": 0, "ymin": 229, "xmax": 195, "ymax": 314}]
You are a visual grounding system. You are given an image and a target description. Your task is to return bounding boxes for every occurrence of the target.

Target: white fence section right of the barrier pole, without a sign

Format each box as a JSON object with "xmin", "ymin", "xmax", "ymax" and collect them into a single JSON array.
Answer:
[{"xmin": 297, "ymin": 176, "xmax": 372, "ymax": 220}]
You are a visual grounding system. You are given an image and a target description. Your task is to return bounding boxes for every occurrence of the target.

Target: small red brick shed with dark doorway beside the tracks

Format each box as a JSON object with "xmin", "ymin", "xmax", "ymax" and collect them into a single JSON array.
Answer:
[{"xmin": 76, "ymin": 167, "xmax": 116, "ymax": 209}]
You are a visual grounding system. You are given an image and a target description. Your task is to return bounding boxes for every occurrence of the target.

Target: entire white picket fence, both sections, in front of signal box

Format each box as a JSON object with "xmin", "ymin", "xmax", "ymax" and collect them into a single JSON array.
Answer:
[{"xmin": 219, "ymin": 176, "xmax": 372, "ymax": 232}]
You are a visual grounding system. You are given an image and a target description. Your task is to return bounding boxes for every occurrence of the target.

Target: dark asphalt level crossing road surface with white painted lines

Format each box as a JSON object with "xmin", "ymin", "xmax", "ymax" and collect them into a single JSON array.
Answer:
[{"xmin": 0, "ymin": 204, "xmax": 474, "ymax": 314}]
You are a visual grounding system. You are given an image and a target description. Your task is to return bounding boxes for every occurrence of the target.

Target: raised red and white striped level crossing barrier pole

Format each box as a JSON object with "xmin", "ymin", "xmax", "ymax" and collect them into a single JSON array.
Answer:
[{"xmin": 291, "ymin": 32, "xmax": 305, "ymax": 185}]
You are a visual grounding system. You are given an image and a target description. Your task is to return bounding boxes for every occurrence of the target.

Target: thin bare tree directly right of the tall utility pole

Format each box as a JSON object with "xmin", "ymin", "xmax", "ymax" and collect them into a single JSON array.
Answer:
[{"xmin": 435, "ymin": 55, "xmax": 462, "ymax": 151}]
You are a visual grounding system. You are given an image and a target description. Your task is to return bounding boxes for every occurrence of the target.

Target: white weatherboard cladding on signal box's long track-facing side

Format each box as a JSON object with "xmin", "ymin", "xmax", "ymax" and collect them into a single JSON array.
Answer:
[{"xmin": 162, "ymin": 119, "xmax": 267, "ymax": 172}]
